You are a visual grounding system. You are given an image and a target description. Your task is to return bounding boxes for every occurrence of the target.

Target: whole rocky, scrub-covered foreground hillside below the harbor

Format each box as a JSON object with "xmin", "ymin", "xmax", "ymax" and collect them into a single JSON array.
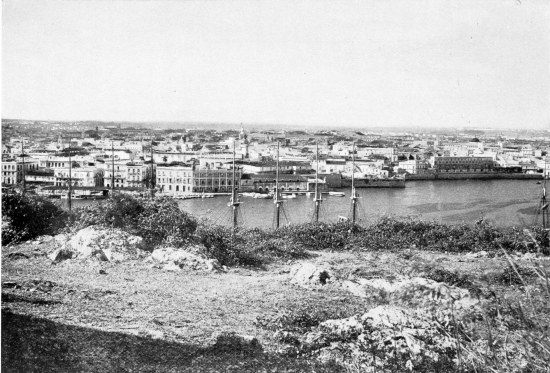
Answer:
[{"xmin": 2, "ymin": 196, "xmax": 550, "ymax": 372}]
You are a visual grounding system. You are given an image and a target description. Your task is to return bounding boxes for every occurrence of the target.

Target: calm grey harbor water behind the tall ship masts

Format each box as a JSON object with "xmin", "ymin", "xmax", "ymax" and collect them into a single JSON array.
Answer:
[{"xmin": 62, "ymin": 180, "xmax": 542, "ymax": 228}]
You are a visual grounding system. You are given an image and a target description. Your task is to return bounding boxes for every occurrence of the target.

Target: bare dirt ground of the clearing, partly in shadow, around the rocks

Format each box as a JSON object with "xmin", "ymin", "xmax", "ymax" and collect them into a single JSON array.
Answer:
[{"xmin": 2, "ymin": 243, "xmax": 544, "ymax": 372}]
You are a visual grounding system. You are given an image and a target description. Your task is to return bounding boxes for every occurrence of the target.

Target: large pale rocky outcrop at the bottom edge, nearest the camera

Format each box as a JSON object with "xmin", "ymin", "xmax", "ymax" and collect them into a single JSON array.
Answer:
[{"xmin": 302, "ymin": 306, "xmax": 456, "ymax": 371}]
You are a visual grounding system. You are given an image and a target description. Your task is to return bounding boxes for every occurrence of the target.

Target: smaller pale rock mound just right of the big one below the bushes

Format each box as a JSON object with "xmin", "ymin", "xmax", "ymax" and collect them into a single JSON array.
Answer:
[{"xmin": 148, "ymin": 246, "xmax": 222, "ymax": 271}]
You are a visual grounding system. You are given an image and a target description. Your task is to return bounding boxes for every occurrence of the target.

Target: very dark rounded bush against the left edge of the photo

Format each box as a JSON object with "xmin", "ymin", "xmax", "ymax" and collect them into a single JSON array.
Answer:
[{"xmin": 2, "ymin": 193, "xmax": 68, "ymax": 245}]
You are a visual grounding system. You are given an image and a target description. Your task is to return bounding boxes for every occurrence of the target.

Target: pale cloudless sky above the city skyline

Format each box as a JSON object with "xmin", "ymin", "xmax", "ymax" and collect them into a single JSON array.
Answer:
[{"xmin": 2, "ymin": 0, "xmax": 550, "ymax": 129}]
